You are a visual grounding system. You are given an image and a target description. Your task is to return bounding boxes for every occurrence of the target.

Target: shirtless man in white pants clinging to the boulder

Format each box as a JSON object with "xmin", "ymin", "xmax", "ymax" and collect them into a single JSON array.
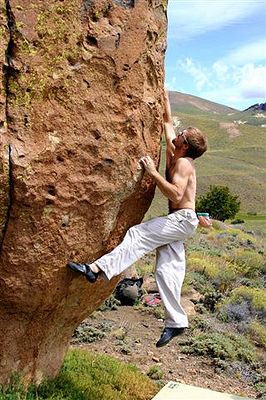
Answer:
[{"xmin": 68, "ymin": 92, "xmax": 207, "ymax": 347}]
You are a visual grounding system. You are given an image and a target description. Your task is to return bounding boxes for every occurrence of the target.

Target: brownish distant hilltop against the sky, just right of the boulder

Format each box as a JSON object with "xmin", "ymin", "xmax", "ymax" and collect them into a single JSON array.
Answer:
[{"xmin": 169, "ymin": 91, "xmax": 239, "ymax": 114}]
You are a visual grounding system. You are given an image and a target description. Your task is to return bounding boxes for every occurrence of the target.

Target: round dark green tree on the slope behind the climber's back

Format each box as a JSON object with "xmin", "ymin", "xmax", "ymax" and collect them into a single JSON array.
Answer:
[{"xmin": 196, "ymin": 185, "xmax": 240, "ymax": 221}]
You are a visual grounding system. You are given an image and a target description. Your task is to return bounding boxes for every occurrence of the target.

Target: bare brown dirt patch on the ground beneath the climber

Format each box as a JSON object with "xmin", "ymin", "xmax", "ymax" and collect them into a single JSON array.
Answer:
[{"xmin": 72, "ymin": 306, "xmax": 256, "ymax": 398}]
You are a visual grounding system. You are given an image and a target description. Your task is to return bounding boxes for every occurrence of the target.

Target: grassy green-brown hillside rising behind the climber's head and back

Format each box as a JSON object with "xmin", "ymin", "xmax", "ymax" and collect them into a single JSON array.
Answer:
[{"xmin": 148, "ymin": 92, "xmax": 266, "ymax": 216}]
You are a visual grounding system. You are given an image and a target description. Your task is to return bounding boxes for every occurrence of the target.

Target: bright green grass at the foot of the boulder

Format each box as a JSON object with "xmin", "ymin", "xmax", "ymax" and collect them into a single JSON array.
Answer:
[{"xmin": 0, "ymin": 350, "xmax": 159, "ymax": 400}]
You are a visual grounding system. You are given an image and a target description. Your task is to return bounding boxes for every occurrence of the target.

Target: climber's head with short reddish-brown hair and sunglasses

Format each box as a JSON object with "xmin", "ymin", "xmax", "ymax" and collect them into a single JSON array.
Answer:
[{"xmin": 178, "ymin": 127, "xmax": 208, "ymax": 160}]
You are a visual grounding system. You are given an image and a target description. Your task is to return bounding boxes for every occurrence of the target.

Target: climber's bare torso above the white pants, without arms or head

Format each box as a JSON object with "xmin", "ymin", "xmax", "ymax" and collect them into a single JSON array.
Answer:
[{"xmin": 166, "ymin": 157, "xmax": 196, "ymax": 212}]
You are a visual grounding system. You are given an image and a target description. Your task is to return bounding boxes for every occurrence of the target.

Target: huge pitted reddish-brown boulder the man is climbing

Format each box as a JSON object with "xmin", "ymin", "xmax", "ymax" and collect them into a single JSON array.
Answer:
[{"xmin": 0, "ymin": 0, "xmax": 166, "ymax": 383}]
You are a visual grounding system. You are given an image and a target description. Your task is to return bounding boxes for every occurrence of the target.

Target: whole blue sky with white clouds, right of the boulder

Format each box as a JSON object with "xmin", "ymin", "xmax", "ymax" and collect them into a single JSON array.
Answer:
[{"xmin": 165, "ymin": 0, "xmax": 266, "ymax": 110}]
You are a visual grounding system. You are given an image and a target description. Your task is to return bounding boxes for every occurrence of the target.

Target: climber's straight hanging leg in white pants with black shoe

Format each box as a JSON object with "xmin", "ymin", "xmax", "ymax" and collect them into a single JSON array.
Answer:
[{"xmin": 155, "ymin": 241, "xmax": 188, "ymax": 347}]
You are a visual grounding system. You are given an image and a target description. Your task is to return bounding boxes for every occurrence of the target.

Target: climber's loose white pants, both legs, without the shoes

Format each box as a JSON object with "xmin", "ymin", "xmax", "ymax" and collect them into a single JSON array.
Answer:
[{"xmin": 95, "ymin": 209, "xmax": 198, "ymax": 328}]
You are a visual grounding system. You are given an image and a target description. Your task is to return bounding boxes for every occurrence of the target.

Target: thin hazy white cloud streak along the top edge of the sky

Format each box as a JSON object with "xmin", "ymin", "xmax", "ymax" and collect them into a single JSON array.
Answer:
[{"xmin": 168, "ymin": 0, "xmax": 265, "ymax": 40}]
